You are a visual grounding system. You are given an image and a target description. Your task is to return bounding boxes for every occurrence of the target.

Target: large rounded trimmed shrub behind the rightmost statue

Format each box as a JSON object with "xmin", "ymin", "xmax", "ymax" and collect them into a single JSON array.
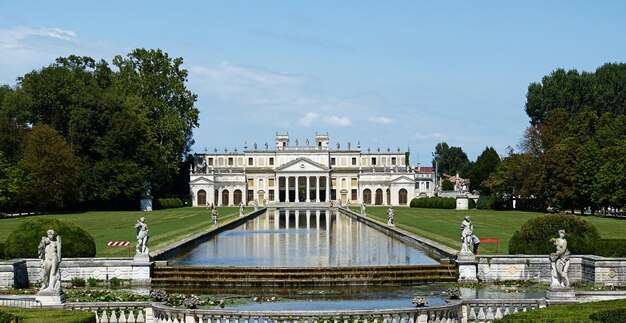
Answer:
[{"xmin": 509, "ymin": 213, "xmax": 600, "ymax": 255}]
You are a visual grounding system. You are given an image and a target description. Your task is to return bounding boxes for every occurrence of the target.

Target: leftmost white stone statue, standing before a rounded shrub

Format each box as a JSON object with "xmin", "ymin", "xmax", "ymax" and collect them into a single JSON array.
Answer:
[{"xmin": 38, "ymin": 229, "xmax": 61, "ymax": 292}]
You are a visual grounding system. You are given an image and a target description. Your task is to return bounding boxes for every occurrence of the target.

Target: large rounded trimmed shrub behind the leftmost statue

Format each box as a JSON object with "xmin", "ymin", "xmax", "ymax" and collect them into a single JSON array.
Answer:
[{"xmin": 4, "ymin": 218, "xmax": 96, "ymax": 259}]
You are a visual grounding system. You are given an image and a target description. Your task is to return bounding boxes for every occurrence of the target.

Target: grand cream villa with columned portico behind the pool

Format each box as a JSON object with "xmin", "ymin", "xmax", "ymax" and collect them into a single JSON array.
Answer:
[{"xmin": 189, "ymin": 134, "xmax": 434, "ymax": 206}]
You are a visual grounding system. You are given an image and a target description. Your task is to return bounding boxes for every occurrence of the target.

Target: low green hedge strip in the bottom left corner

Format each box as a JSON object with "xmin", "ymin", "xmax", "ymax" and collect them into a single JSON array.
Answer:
[{"xmin": 0, "ymin": 307, "xmax": 96, "ymax": 323}]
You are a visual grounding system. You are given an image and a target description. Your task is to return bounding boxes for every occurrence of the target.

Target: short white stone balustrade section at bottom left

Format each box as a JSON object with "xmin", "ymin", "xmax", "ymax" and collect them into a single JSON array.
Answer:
[{"xmin": 64, "ymin": 302, "xmax": 155, "ymax": 323}]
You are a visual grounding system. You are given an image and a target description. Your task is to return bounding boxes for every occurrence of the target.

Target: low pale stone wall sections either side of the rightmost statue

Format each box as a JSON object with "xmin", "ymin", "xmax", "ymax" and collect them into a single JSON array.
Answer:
[{"xmin": 477, "ymin": 255, "xmax": 626, "ymax": 286}]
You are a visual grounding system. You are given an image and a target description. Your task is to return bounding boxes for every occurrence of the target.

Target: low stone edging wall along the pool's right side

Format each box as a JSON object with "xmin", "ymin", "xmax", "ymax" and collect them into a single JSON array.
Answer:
[{"xmin": 338, "ymin": 208, "xmax": 458, "ymax": 260}]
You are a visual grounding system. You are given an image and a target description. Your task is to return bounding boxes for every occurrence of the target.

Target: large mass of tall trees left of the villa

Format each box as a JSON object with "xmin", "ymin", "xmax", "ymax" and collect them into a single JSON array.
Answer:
[{"xmin": 0, "ymin": 49, "xmax": 199, "ymax": 212}]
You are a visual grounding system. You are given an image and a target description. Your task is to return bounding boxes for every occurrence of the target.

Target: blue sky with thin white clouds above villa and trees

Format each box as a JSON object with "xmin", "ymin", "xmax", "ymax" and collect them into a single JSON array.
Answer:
[{"xmin": 0, "ymin": 0, "xmax": 626, "ymax": 165}]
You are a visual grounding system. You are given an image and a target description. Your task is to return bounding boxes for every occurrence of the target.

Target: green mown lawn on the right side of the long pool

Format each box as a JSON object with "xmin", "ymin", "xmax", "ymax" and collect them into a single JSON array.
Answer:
[{"xmin": 352, "ymin": 207, "xmax": 626, "ymax": 254}]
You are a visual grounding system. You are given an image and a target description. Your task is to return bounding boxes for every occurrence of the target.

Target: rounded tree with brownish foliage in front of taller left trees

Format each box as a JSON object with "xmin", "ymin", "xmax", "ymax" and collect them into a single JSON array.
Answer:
[{"xmin": 19, "ymin": 124, "xmax": 79, "ymax": 211}]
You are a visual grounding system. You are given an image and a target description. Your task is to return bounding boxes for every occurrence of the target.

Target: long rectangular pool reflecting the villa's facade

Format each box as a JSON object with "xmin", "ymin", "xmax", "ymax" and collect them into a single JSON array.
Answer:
[{"xmin": 169, "ymin": 209, "xmax": 438, "ymax": 267}]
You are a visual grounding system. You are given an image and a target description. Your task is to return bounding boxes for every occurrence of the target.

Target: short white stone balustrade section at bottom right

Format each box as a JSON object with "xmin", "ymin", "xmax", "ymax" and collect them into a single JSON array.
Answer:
[{"xmin": 461, "ymin": 298, "xmax": 547, "ymax": 322}]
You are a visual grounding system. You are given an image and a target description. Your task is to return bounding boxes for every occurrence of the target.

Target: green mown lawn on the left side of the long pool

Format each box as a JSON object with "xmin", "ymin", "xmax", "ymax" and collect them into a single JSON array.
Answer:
[{"xmin": 0, "ymin": 207, "xmax": 239, "ymax": 257}]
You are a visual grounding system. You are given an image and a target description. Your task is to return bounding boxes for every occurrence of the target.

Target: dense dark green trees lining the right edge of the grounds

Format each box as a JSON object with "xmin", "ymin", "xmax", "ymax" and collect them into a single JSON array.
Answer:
[{"xmin": 485, "ymin": 63, "xmax": 626, "ymax": 212}]
